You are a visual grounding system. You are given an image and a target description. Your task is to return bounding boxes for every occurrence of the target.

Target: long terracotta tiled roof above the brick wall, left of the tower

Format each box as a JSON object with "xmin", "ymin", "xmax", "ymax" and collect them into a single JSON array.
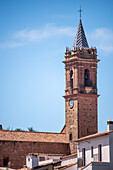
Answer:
[{"xmin": 0, "ymin": 130, "xmax": 68, "ymax": 143}]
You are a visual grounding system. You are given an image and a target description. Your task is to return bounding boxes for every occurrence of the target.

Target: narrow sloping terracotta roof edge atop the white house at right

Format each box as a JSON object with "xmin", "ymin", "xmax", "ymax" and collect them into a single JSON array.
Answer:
[{"xmin": 75, "ymin": 130, "xmax": 113, "ymax": 142}]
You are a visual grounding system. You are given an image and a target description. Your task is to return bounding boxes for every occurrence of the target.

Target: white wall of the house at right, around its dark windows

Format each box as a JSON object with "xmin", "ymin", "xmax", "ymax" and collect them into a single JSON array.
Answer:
[{"xmin": 78, "ymin": 135, "xmax": 110, "ymax": 165}]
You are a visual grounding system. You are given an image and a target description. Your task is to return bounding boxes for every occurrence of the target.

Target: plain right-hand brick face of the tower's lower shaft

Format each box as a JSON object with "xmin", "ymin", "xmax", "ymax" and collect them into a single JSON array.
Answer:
[{"xmin": 78, "ymin": 96, "xmax": 97, "ymax": 138}]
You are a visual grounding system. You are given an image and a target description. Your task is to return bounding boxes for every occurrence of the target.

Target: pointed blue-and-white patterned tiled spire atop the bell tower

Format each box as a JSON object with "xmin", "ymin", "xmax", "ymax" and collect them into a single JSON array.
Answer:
[{"xmin": 73, "ymin": 19, "xmax": 89, "ymax": 49}]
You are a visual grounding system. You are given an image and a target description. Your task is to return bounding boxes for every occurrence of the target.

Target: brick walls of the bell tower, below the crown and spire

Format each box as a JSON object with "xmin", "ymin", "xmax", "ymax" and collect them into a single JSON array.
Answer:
[{"xmin": 65, "ymin": 56, "xmax": 98, "ymax": 154}]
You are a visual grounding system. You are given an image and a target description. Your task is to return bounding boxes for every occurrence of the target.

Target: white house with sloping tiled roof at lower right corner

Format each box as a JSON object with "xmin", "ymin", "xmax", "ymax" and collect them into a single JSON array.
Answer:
[{"xmin": 77, "ymin": 125, "xmax": 113, "ymax": 170}]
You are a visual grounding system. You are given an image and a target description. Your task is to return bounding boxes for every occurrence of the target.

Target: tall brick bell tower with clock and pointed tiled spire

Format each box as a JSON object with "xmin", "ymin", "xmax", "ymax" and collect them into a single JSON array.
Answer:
[{"xmin": 63, "ymin": 19, "xmax": 99, "ymax": 154}]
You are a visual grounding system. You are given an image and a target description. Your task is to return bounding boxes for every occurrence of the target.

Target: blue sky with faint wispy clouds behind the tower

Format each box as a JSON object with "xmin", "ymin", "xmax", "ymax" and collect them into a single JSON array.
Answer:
[{"xmin": 0, "ymin": 0, "xmax": 113, "ymax": 132}]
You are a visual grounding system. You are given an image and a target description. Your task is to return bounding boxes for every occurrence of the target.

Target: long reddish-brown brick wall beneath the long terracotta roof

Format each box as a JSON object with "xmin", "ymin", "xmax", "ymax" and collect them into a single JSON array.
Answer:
[{"xmin": 0, "ymin": 141, "xmax": 68, "ymax": 168}]
